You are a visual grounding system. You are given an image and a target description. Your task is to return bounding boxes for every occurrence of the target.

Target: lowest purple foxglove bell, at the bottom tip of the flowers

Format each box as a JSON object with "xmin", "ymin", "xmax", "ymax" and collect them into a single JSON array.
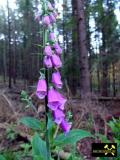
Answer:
[{"xmin": 60, "ymin": 120, "xmax": 71, "ymax": 134}]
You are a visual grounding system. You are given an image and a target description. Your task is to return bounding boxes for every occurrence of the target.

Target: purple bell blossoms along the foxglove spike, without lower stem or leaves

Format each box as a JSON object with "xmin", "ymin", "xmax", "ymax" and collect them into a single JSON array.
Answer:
[{"xmin": 36, "ymin": 2, "xmax": 71, "ymax": 133}]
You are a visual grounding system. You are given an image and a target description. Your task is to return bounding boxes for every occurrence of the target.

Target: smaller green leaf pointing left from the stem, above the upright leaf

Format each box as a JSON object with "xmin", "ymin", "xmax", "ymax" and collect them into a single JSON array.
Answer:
[{"xmin": 19, "ymin": 117, "xmax": 43, "ymax": 130}]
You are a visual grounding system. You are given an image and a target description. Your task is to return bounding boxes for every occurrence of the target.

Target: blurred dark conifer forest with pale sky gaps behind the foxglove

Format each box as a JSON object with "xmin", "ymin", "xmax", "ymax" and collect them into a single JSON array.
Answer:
[{"xmin": 0, "ymin": 0, "xmax": 120, "ymax": 96}]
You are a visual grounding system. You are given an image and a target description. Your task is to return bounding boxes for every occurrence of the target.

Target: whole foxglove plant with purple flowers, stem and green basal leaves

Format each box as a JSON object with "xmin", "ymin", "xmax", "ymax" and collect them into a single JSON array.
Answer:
[{"xmin": 20, "ymin": 0, "xmax": 91, "ymax": 160}]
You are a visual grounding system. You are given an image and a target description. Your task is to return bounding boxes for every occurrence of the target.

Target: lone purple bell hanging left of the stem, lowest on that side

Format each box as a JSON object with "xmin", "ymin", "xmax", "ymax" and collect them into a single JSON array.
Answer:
[{"xmin": 36, "ymin": 79, "xmax": 47, "ymax": 99}]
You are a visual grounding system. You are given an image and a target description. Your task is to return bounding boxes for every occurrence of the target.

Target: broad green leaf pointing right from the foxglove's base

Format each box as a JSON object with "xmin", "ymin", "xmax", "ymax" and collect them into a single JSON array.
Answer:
[{"xmin": 54, "ymin": 129, "xmax": 93, "ymax": 146}]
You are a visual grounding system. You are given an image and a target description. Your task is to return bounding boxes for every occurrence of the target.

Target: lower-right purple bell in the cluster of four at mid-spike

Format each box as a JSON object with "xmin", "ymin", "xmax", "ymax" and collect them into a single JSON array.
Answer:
[{"xmin": 52, "ymin": 54, "xmax": 62, "ymax": 68}]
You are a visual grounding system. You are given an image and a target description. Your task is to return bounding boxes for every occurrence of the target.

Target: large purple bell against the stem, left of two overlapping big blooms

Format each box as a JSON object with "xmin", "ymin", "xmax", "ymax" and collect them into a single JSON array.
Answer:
[{"xmin": 48, "ymin": 88, "xmax": 60, "ymax": 111}]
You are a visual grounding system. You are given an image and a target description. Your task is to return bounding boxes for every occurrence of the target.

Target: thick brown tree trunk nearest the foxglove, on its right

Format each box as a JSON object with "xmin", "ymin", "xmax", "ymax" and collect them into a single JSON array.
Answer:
[{"xmin": 77, "ymin": 0, "xmax": 90, "ymax": 97}]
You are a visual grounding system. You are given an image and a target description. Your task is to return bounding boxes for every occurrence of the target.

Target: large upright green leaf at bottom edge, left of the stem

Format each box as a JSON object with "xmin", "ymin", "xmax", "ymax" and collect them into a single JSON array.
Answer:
[{"xmin": 32, "ymin": 133, "xmax": 47, "ymax": 160}]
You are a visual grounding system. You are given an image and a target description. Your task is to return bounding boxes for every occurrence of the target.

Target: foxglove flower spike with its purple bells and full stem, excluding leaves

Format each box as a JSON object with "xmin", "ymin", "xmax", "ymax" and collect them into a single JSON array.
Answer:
[{"xmin": 35, "ymin": 0, "xmax": 71, "ymax": 159}]
